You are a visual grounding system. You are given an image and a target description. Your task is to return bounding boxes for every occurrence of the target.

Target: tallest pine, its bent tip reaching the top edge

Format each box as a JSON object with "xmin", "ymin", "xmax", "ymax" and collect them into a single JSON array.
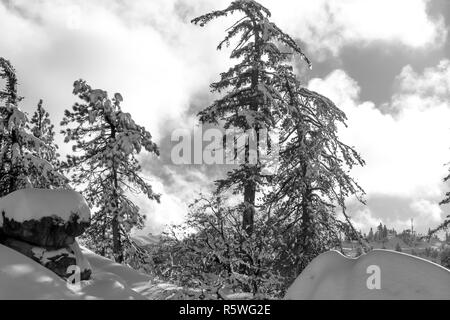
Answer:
[{"xmin": 192, "ymin": 0, "xmax": 309, "ymax": 234}]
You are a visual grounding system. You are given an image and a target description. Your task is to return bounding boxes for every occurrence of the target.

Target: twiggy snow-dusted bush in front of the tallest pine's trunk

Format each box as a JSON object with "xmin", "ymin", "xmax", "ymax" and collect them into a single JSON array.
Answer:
[{"xmin": 153, "ymin": 198, "xmax": 282, "ymax": 297}]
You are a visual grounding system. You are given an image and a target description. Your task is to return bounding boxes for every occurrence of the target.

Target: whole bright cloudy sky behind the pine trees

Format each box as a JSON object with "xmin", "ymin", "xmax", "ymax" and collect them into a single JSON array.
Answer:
[{"xmin": 0, "ymin": 0, "xmax": 450, "ymax": 232}]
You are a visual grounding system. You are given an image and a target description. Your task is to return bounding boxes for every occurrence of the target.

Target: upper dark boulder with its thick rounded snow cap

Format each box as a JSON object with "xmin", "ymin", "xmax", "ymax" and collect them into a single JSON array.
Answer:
[{"xmin": 0, "ymin": 189, "xmax": 90, "ymax": 248}]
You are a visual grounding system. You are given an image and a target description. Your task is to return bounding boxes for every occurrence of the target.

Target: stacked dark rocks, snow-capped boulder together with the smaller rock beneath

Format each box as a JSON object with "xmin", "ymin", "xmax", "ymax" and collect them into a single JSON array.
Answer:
[{"xmin": 0, "ymin": 189, "xmax": 92, "ymax": 280}]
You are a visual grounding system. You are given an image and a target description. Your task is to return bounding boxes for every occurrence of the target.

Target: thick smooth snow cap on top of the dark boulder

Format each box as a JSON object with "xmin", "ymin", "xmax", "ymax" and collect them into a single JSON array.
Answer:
[{"xmin": 0, "ymin": 188, "xmax": 91, "ymax": 227}]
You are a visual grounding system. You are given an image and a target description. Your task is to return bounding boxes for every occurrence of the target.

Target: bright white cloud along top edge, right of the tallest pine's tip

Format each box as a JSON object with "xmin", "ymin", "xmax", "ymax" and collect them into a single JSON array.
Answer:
[{"xmin": 262, "ymin": 0, "xmax": 447, "ymax": 58}]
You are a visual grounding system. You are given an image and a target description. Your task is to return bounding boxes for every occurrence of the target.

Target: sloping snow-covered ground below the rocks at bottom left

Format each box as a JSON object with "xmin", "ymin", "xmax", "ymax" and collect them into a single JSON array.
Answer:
[{"xmin": 0, "ymin": 245, "xmax": 183, "ymax": 300}]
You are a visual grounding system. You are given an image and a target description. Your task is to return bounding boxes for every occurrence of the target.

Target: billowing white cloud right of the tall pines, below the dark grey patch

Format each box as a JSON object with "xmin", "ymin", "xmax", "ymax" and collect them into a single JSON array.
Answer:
[{"xmin": 309, "ymin": 60, "xmax": 450, "ymax": 232}]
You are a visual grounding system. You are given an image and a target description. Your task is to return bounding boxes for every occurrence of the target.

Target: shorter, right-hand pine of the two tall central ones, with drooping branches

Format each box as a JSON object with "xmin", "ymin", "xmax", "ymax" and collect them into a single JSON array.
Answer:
[{"xmin": 264, "ymin": 69, "xmax": 364, "ymax": 278}]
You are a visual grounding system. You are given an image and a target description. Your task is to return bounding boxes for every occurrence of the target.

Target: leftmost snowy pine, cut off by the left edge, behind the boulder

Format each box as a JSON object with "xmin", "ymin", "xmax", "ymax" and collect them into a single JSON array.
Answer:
[{"xmin": 0, "ymin": 57, "xmax": 67, "ymax": 196}]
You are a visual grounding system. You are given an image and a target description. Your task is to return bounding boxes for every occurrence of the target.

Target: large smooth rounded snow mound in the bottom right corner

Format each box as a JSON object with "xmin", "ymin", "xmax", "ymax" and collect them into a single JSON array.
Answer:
[{"xmin": 286, "ymin": 250, "xmax": 450, "ymax": 300}]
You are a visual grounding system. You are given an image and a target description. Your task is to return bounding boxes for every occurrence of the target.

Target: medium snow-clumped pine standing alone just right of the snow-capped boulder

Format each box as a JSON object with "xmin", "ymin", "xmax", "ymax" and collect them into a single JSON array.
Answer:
[{"xmin": 61, "ymin": 80, "xmax": 160, "ymax": 262}]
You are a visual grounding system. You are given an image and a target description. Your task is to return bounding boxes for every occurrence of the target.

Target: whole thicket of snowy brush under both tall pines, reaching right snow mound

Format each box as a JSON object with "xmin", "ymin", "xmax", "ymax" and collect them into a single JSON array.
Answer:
[{"xmin": 152, "ymin": 192, "xmax": 360, "ymax": 298}]
